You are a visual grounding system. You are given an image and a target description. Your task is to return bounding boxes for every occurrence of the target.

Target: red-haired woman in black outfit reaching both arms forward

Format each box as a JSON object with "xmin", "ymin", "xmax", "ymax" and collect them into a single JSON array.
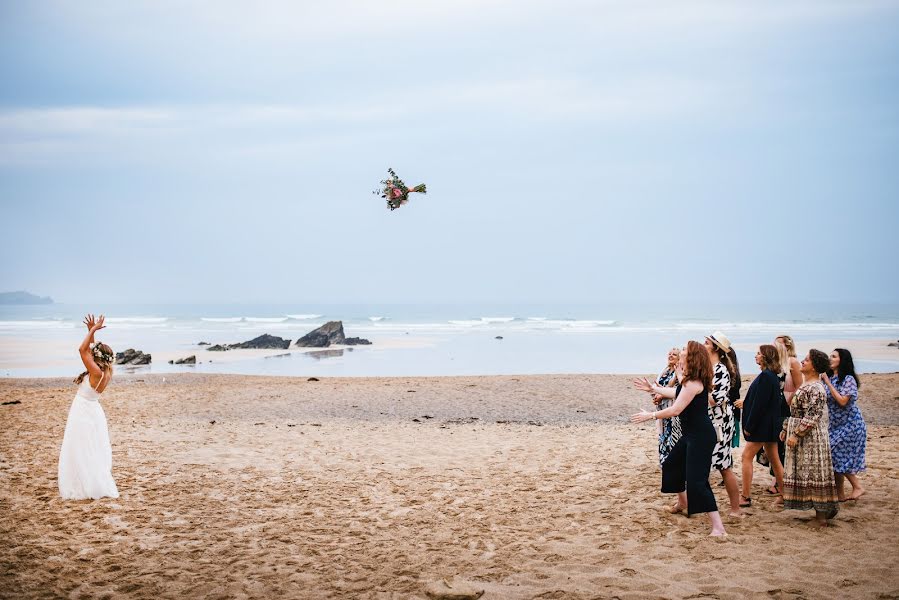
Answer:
[{"xmin": 631, "ymin": 341, "xmax": 727, "ymax": 536}]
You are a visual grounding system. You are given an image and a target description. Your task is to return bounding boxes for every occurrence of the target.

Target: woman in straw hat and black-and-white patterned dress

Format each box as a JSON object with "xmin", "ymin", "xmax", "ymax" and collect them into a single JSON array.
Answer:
[{"xmin": 705, "ymin": 331, "xmax": 743, "ymax": 517}]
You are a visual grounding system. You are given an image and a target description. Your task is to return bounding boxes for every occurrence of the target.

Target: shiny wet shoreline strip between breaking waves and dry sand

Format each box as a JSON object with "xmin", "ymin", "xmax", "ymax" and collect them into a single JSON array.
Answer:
[{"xmin": 0, "ymin": 335, "xmax": 899, "ymax": 379}]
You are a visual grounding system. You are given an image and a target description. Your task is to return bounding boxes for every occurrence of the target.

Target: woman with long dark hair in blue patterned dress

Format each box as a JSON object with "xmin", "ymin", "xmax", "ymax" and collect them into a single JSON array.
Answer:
[{"xmin": 821, "ymin": 348, "xmax": 868, "ymax": 500}]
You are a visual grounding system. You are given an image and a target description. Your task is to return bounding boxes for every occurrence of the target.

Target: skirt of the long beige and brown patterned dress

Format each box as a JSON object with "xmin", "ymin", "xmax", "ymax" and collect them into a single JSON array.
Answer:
[{"xmin": 783, "ymin": 417, "xmax": 839, "ymax": 513}]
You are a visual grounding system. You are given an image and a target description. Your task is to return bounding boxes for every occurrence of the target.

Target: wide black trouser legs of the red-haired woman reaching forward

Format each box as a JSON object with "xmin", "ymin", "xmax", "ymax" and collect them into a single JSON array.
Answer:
[{"xmin": 662, "ymin": 427, "xmax": 718, "ymax": 515}]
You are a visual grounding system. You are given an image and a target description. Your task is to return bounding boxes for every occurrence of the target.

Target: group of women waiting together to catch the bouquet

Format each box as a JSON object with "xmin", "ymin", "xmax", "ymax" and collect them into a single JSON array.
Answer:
[{"xmin": 631, "ymin": 331, "xmax": 867, "ymax": 536}]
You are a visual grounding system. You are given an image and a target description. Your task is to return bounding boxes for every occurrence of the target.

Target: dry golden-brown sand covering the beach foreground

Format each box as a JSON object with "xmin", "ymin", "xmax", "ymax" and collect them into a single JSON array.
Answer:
[{"xmin": 0, "ymin": 374, "xmax": 899, "ymax": 599}]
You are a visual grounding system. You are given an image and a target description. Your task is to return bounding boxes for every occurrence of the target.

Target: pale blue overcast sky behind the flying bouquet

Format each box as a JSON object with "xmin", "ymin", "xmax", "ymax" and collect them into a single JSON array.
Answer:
[{"xmin": 0, "ymin": 0, "xmax": 899, "ymax": 303}]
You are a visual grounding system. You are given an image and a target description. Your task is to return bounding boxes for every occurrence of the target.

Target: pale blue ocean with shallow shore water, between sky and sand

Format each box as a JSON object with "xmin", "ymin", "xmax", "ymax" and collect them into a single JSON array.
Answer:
[{"xmin": 0, "ymin": 304, "xmax": 899, "ymax": 377}]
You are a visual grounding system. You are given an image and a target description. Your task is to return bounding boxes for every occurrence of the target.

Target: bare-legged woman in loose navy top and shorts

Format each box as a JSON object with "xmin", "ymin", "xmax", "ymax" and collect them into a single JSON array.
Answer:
[{"xmin": 740, "ymin": 344, "xmax": 783, "ymax": 508}]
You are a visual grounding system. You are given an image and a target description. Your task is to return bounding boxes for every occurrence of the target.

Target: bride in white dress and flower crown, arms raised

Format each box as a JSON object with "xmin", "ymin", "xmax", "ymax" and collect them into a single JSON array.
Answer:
[{"xmin": 59, "ymin": 315, "xmax": 119, "ymax": 500}]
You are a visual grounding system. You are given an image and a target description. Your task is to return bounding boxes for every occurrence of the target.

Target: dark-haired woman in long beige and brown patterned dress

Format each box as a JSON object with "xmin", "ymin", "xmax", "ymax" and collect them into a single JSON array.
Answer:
[{"xmin": 780, "ymin": 350, "xmax": 839, "ymax": 527}]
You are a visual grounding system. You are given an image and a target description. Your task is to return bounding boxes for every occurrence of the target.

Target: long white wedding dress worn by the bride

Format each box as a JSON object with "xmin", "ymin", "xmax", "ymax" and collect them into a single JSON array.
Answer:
[{"xmin": 59, "ymin": 375, "xmax": 119, "ymax": 500}]
